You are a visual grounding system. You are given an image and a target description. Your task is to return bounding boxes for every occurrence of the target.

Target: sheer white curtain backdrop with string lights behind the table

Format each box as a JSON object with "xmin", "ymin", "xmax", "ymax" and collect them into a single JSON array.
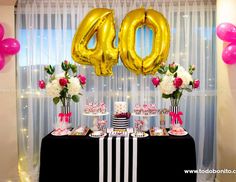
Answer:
[{"xmin": 16, "ymin": 0, "xmax": 216, "ymax": 181}]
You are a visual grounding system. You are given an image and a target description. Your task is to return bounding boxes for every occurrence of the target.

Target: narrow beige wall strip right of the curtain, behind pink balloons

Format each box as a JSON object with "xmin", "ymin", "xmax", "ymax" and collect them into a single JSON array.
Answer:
[{"xmin": 216, "ymin": 0, "xmax": 236, "ymax": 182}]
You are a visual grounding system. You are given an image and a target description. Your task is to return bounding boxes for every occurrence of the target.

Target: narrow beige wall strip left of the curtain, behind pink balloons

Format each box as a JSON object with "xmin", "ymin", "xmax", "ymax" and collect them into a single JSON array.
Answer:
[{"xmin": 0, "ymin": 0, "xmax": 18, "ymax": 181}]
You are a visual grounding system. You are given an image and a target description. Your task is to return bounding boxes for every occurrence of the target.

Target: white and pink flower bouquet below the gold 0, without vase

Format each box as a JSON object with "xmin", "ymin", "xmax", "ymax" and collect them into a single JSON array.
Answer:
[{"xmin": 152, "ymin": 63, "xmax": 200, "ymax": 106}]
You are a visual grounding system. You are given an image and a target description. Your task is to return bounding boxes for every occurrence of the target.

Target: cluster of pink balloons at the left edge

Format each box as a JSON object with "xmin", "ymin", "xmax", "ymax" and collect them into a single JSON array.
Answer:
[{"xmin": 0, "ymin": 24, "xmax": 20, "ymax": 70}]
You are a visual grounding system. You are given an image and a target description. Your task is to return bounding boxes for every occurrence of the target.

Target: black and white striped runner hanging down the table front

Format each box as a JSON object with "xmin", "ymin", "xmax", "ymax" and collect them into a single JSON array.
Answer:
[{"xmin": 99, "ymin": 137, "xmax": 138, "ymax": 182}]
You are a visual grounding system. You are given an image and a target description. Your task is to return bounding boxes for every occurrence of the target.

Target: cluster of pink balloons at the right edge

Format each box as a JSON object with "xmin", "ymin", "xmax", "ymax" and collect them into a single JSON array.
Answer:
[{"xmin": 216, "ymin": 23, "xmax": 236, "ymax": 64}]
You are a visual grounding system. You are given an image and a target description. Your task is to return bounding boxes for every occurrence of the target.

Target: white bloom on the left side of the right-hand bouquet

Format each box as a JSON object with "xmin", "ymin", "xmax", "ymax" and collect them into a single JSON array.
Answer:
[{"xmin": 160, "ymin": 76, "xmax": 176, "ymax": 95}]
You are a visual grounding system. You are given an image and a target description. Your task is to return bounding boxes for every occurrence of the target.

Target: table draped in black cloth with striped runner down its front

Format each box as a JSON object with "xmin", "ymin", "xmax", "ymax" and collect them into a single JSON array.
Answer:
[{"xmin": 39, "ymin": 130, "xmax": 196, "ymax": 182}]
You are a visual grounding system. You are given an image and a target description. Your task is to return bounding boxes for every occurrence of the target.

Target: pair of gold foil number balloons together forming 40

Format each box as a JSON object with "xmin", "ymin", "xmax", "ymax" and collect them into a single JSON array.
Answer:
[{"xmin": 72, "ymin": 8, "xmax": 170, "ymax": 76}]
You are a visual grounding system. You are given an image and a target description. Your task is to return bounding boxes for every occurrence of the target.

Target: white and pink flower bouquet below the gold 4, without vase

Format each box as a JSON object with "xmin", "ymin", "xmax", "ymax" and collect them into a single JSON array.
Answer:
[{"xmin": 38, "ymin": 60, "xmax": 86, "ymax": 106}]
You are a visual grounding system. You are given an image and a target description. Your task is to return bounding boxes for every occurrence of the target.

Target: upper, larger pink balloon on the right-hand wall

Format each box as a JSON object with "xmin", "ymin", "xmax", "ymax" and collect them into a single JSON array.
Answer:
[{"xmin": 216, "ymin": 23, "xmax": 236, "ymax": 42}]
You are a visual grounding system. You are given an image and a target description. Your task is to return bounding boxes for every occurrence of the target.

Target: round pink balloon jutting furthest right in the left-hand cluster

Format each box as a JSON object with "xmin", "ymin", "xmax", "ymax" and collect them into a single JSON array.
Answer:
[{"xmin": 0, "ymin": 38, "xmax": 20, "ymax": 55}]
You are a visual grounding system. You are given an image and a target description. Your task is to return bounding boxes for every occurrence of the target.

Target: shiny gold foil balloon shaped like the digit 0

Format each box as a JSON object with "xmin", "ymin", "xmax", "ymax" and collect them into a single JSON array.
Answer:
[{"xmin": 119, "ymin": 8, "xmax": 170, "ymax": 75}]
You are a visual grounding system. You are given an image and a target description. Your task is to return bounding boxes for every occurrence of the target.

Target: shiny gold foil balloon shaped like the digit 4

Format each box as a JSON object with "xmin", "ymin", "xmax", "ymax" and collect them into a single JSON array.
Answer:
[{"xmin": 72, "ymin": 8, "xmax": 118, "ymax": 76}]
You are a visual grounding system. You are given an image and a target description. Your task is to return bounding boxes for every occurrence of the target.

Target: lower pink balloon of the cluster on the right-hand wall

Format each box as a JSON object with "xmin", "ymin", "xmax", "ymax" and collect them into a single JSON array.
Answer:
[{"xmin": 222, "ymin": 43, "xmax": 236, "ymax": 64}]
